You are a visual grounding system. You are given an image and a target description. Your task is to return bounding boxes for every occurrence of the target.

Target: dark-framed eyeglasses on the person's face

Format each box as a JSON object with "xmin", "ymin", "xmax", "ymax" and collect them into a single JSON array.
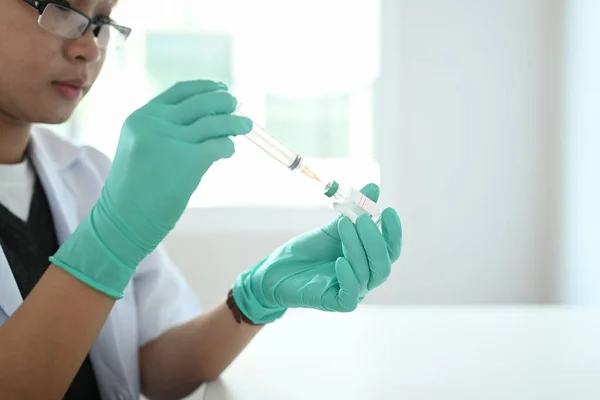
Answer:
[{"xmin": 24, "ymin": 0, "xmax": 131, "ymax": 49}]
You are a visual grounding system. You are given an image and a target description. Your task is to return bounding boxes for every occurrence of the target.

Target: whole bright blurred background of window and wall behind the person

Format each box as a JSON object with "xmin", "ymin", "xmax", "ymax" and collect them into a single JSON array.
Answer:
[{"xmin": 50, "ymin": 0, "xmax": 600, "ymax": 307}]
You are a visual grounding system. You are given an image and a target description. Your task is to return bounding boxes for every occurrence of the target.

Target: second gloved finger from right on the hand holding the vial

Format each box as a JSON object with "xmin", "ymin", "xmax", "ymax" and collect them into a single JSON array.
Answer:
[{"xmin": 356, "ymin": 214, "xmax": 391, "ymax": 290}]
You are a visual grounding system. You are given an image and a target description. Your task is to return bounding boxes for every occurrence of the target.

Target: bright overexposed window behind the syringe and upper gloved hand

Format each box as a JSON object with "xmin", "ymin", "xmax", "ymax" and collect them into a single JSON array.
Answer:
[{"xmin": 64, "ymin": 0, "xmax": 379, "ymax": 207}]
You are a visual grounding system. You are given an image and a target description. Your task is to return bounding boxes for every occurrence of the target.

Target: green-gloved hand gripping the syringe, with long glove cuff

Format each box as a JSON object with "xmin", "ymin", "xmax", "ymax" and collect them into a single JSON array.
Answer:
[{"xmin": 50, "ymin": 81, "xmax": 252, "ymax": 298}]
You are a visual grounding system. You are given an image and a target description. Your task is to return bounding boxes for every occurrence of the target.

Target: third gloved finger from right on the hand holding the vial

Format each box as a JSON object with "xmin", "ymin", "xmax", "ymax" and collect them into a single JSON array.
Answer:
[{"xmin": 338, "ymin": 217, "xmax": 371, "ymax": 291}]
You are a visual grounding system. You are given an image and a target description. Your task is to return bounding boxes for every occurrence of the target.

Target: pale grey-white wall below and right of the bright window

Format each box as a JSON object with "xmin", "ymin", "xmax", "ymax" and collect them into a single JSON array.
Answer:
[{"xmin": 167, "ymin": 0, "xmax": 562, "ymax": 305}]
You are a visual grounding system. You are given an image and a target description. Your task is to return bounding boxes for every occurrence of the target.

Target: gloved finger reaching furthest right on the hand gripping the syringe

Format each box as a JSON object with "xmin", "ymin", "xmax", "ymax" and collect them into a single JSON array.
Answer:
[{"xmin": 178, "ymin": 114, "xmax": 252, "ymax": 143}]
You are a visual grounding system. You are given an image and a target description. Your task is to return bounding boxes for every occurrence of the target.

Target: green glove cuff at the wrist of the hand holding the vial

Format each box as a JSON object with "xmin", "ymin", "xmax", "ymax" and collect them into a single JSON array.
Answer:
[{"xmin": 228, "ymin": 270, "xmax": 287, "ymax": 325}]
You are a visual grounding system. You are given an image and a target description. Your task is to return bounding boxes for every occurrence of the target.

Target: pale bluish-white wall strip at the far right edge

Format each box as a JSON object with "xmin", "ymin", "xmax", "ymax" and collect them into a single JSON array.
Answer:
[{"xmin": 559, "ymin": 0, "xmax": 600, "ymax": 304}]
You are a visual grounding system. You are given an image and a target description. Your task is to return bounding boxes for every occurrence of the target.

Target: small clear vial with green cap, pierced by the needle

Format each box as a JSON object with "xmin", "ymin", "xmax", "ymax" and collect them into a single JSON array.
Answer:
[{"xmin": 324, "ymin": 181, "xmax": 381, "ymax": 226}]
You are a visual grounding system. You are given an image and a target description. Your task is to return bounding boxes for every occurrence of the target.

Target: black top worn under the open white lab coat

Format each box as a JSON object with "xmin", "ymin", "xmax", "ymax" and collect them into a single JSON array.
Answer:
[{"xmin": 0, "ymin": 163, "xmax": 100, "ymax": 400}]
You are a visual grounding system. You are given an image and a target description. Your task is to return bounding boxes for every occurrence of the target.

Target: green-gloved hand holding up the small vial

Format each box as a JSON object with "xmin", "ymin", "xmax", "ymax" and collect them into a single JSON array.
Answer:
[{"xmin": 232, "ymin": 184, "xmax": 402, "ymax": 324}]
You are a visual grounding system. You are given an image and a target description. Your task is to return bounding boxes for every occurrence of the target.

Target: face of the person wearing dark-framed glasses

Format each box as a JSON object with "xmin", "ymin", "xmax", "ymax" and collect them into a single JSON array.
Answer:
[{"xmin": 0, "ymin": 0, "xmax": 111, "ymax": 124}]
